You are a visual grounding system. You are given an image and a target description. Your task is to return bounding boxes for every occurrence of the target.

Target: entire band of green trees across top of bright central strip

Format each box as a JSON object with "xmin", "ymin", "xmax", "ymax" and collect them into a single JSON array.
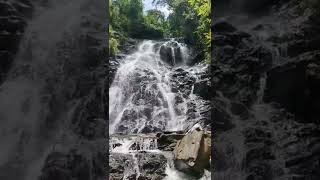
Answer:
[{"xmin": 109, "ymin": 0, "xmax": 211, "ymax": 61}]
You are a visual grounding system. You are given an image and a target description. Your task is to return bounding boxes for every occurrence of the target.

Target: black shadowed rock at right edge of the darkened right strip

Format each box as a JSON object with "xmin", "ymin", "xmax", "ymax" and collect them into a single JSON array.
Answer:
[{"xmin": 265, "ymin": 51, "xmax": 320, "ymax": 122}]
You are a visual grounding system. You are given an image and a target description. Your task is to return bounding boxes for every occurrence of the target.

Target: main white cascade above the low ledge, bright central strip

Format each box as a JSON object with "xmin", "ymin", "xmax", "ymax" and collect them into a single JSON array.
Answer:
[{"xmin": 109, "ymin": 40, "xmax": 203, "ymax": 134}]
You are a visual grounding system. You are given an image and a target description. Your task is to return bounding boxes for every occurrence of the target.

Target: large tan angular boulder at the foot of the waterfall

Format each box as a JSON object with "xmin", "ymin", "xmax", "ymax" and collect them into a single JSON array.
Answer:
[{"xmin": 174, "ymin": 129, "xmax": 211, "ymax": 177}]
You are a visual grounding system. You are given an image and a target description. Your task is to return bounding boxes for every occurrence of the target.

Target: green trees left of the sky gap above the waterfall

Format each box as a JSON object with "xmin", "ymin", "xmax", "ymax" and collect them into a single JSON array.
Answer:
[{"xmin": 109, "ymin": 0, "xmax": 168, "ymax": 51}]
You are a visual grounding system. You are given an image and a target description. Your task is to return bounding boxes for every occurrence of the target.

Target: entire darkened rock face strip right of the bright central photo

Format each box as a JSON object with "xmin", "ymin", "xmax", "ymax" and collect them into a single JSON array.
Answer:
[{"xmin": 210, "ymin": 0, "xmax": 320, "ymax": 180}]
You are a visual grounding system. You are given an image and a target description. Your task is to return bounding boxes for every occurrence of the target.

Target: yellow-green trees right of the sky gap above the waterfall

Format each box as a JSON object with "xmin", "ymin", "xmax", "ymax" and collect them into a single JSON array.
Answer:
[{"xmin": 153, "ymin": 0, "xmax": 211, "ymax": 62}]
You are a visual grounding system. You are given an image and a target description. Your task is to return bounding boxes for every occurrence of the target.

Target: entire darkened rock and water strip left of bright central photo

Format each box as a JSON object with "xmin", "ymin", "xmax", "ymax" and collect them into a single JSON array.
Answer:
[{"xmin": 0, "ymin": 0, "xmax": 108, "ymax": 180}]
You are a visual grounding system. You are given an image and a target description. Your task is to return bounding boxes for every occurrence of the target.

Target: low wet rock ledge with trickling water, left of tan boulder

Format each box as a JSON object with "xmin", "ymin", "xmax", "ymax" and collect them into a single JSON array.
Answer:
[{"xmin": 109, "ymin": 132, "xmax": 191, "ymax": 180}]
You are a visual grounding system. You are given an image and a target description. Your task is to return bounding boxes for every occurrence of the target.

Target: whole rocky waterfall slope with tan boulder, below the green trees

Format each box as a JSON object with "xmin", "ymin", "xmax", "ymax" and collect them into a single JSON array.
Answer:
[{"xmin": 109, "ymin": 39, "xmax": 211, "ymax": 180}]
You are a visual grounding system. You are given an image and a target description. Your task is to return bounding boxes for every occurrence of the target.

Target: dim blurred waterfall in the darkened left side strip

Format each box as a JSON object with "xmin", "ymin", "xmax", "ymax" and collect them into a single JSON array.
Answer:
[{"xmin": 0, "ymin": 0, "xmax": 105, "ymax": 180}]
